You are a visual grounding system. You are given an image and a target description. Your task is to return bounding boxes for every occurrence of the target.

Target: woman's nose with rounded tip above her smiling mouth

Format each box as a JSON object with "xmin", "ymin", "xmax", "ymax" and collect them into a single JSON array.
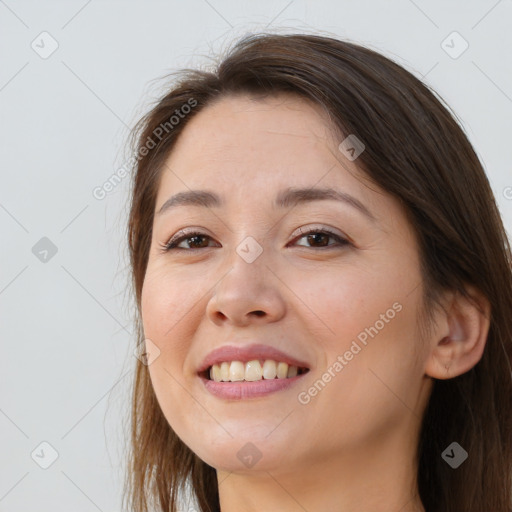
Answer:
[{"xmin": 206, "ymin": 248, "xmax": 286, "ymax": 327}]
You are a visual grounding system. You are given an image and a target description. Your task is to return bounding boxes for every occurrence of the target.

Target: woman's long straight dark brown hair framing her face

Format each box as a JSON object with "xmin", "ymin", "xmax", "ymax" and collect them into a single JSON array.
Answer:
[{"xmin": 125, "ymin": 33, "xmax": 512, "ymax": 512}]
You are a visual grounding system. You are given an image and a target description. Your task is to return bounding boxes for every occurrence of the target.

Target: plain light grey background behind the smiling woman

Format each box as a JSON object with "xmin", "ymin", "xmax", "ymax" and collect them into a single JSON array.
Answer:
[{"xmin": 0, "ymin": 0, "xmax": 512, "ymax": 512}]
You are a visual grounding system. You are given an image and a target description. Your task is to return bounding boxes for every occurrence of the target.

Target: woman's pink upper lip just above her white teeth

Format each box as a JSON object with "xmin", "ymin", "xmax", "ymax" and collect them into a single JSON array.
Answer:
[{"xmin": 197, "ymin": 343, "xmax": 309, "ymax": 373}]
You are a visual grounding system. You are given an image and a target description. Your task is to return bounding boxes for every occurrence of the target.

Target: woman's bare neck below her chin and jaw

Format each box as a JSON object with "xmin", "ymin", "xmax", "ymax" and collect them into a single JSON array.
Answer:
[{"xmin": 217, "ymin": 418, "xmax": 425, "ymax": 512}]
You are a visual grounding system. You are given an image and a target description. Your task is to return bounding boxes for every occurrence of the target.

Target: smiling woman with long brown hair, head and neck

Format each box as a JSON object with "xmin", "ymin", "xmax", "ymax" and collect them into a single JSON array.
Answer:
[{"xmin": 123, "ymin": 34, "xmax": 512, "ymax": 512}]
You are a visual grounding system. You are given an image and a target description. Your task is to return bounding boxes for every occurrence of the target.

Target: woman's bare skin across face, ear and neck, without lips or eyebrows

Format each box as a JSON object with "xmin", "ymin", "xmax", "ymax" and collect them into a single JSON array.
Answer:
[{"xmin": 141, "ymin": 96, "xmax": 488, "ymax": 512}]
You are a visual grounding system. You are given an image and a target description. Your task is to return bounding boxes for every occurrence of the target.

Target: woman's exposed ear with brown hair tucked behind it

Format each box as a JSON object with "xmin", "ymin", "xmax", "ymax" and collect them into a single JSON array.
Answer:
[{"xmin": 425, "ymin": 286, "xmax": 491, "ymax": 379}]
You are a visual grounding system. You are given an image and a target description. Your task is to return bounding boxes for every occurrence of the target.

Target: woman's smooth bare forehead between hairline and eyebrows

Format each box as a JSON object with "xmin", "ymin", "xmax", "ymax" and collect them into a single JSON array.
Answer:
[{"xmin": 154, "ymin": 94, "xmax": 375, "ymax": 200}]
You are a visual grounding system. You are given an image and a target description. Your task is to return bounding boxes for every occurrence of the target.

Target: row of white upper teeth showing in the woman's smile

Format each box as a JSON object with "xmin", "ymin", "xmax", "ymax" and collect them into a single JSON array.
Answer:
[{"xmin": 210, "ymin": 359, "xmax": 298, "ymax": 382}]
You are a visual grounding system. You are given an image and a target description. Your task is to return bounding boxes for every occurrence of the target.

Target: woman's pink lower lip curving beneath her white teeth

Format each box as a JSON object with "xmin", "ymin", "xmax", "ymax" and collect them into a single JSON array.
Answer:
[{"xmin": 199, "ymin": 372, "xmax": 309, "ymax": 400}]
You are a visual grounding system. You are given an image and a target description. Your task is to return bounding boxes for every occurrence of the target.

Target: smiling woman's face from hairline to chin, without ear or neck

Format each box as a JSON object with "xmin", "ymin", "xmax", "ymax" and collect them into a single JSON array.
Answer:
[{"xmin": 142, "ymin": 96, "xmax": 429, "ymax": 471}]
